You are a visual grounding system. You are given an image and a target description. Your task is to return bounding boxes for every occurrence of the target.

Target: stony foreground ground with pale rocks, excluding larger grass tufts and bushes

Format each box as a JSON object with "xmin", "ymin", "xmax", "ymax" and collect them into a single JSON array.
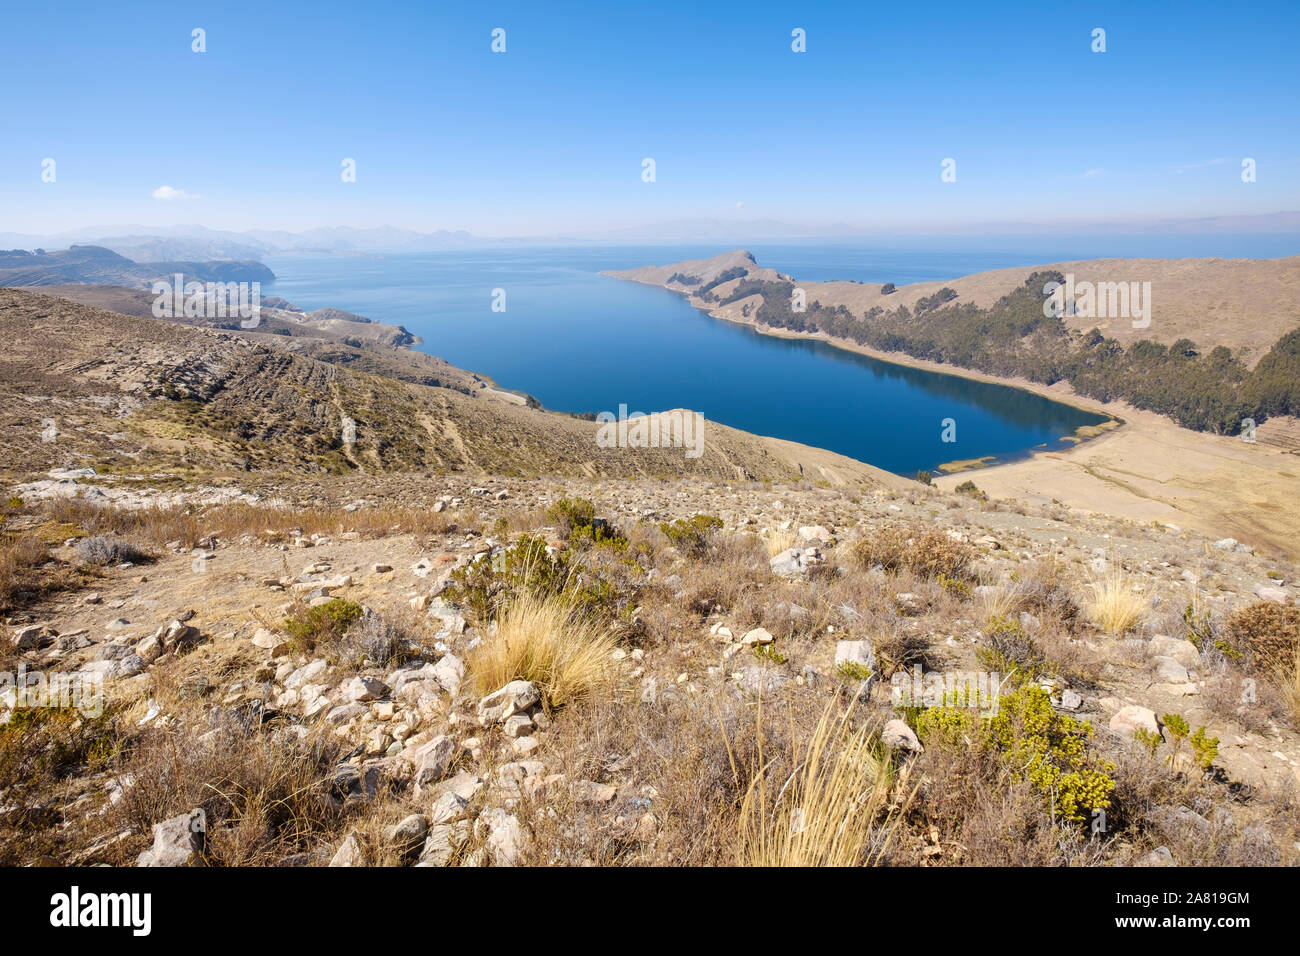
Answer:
[{"xmin": 0, "ymin": 473, "xmax": 1300, "ymax": 865}]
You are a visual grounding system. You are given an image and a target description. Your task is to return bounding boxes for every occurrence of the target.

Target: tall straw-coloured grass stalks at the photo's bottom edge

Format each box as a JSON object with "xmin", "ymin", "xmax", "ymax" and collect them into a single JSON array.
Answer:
[{"xmin": 737, "ymin": 700, "xmax": 902, "ymax": 866}]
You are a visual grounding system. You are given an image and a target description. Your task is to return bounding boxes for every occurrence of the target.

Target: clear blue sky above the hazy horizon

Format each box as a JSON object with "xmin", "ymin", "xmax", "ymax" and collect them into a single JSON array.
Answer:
[{"xmin": 0, "ymin": 0, "xmax": 1300, "ymax": 235}]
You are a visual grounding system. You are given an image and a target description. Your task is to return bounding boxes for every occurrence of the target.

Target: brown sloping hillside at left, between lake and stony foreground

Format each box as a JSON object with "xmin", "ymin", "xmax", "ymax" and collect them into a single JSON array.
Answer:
[{"xmin": 0, "ymin": 290, "xmax": 900, "ymax": 486}]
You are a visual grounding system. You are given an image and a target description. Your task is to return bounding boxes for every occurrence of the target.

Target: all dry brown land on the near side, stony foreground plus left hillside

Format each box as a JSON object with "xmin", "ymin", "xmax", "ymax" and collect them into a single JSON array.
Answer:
[{"xmin": 0, "ymin": 290, "xmax": 1300, "ymax": 866}]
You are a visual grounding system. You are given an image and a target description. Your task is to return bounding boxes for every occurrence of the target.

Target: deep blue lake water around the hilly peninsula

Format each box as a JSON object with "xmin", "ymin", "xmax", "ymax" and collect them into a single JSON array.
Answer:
[{"xmin": 264, "ymin": 237, "xmax": 1295, "ymax": 475}]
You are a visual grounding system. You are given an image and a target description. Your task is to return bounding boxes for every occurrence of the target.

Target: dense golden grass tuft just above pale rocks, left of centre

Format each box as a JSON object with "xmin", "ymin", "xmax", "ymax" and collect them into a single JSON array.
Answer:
[{"xmin": 465, "ymin": 594, "xmax": 618, "ymax": 706}]
